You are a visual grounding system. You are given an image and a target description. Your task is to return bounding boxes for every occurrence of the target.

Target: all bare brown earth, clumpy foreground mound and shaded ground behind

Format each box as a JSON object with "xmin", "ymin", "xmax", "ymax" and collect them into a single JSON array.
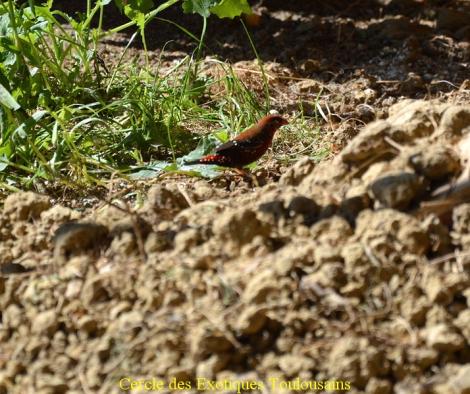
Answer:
[{"xmin": 0, "ymin": 0, "xmax": 470, "ymax": 394}]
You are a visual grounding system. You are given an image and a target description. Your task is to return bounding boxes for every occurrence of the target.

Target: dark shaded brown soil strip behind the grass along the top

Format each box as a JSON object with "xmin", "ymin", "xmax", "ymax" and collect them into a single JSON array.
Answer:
[{"xmin": 56, "ymin": 0, "xmax": 470, "ymax": 97}]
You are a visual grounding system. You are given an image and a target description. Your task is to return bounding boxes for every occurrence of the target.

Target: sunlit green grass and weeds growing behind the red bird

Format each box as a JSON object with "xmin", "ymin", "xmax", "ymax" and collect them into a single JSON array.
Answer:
[{"xmin": 0, "ymin": 0, "xmax": 324, "ymax": 189}]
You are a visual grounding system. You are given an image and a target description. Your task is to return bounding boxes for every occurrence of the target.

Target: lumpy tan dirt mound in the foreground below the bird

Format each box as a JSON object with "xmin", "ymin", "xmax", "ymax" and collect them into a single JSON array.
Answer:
[{"xmin": 0, "ymin": 101, "xmax": 470, "ymax": 393}]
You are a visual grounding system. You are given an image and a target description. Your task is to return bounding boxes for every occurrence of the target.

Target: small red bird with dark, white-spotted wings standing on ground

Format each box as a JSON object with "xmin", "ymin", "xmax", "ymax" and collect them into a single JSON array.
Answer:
[{"xmin": 186, "ymin": 115, "xmax": 288, "ymax": 169}]
